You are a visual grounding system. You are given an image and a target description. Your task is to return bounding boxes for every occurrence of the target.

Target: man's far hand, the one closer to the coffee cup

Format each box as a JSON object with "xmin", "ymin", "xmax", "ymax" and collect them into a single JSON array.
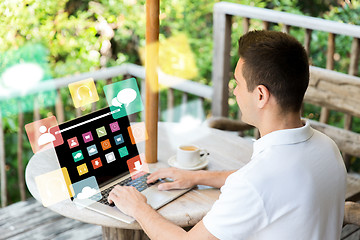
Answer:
[{"xmin": 147, "ymin": 168, "xmax": 196, "ymax": 190}]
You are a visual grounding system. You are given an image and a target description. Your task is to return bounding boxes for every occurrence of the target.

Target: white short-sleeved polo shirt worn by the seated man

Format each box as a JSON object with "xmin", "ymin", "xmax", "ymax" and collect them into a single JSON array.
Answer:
[{"xmin": 203, "ymin": 122, "xmax": 346, "ymax": 240}]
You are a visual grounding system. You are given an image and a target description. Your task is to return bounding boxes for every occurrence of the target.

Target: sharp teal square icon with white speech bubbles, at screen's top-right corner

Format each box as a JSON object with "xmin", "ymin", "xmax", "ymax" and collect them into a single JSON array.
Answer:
[{"xmin": 104, "ymin": 78, "xmax": 144, "ymax": 119}]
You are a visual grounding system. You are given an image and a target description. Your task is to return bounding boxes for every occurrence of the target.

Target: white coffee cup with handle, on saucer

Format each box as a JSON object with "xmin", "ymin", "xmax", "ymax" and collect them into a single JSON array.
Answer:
[{"xmin": 176, "ymin": 144, "xmax": 207, "ymax": 167}]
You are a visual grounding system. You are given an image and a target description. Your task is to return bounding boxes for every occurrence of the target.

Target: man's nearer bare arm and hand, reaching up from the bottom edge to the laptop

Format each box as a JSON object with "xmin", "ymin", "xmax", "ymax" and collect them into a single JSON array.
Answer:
[{"xmin": 108, "ymin": 186, "xmax": 217, "ymax": 240}]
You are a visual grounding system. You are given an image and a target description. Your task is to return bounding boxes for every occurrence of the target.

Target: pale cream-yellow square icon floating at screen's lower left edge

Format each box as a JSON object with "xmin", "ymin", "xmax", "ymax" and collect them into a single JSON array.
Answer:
[{"xmin": 35, "ymin": 167, "xmax": 73, "ymax": 207}]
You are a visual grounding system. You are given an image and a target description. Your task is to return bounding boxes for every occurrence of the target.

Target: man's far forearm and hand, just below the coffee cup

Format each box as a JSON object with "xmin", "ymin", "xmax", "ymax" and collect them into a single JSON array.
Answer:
[{"xmin": 147, "ymin": 168, "xmax": 235, "ymax": 190}]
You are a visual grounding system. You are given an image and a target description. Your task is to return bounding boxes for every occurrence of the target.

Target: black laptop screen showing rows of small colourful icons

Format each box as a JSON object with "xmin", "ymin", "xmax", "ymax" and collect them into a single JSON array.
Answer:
[{"xmin": 55, "ymin": 107, "xmax": 139, "ymax": 187}]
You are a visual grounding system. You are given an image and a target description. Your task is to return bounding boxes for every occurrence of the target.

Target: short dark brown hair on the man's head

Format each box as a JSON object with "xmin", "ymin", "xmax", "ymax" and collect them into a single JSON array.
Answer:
[{"xmin": 239, "ymin": 31, "xmax": 309, "ymax": 112}]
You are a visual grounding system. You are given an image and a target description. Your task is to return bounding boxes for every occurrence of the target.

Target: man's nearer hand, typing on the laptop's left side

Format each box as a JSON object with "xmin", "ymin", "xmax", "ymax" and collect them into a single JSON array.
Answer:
[{"xmin": 108, "ymin": 185, "xmax": 147, "ymax": 217}]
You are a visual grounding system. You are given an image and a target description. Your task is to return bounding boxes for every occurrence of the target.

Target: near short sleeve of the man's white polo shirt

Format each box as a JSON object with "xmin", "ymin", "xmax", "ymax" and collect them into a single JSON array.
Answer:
[{"xmin": 203, "ymin": 176, "xmax": 268, "ymax": 240}]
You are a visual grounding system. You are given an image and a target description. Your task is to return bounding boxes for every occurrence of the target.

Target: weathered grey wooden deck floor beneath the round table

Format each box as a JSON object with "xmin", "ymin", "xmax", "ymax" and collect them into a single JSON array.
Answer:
[{"xmin": 0, "ymin": 198, "xmax": 360, "ymax": 240}]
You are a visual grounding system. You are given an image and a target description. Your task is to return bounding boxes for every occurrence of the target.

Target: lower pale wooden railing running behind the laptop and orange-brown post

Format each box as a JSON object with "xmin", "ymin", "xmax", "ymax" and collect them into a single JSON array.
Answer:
[{"xmin": 0, "ymin": 64, "xmax": 213, "ymax": 207}]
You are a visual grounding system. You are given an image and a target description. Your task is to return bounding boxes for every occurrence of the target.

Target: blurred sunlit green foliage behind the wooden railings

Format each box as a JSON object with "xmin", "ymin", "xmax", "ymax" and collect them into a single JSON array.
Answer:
[{"xmin": 0, "ymin": 0, "xmax": 360, "ymax": 203}]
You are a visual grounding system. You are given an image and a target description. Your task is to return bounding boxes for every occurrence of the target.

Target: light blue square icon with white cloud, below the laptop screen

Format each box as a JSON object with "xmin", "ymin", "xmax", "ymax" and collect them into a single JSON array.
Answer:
[{"xmin": 72, "ymin": 176, "xmax": 102, "ymax": 209}]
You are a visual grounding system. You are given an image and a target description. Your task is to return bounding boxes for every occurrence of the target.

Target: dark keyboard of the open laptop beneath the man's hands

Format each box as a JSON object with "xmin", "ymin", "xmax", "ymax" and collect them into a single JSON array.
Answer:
[{"xmin": 99, "ymin": 173, "xmax": 156, "ymax": 206}]
